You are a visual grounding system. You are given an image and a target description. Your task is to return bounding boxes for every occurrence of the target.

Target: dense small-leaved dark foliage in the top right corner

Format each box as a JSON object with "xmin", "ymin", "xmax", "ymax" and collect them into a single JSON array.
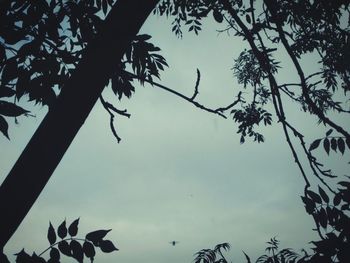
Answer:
[{"xmin": 279, "ymin": 1, "xmax": 350, "ymax": 92}]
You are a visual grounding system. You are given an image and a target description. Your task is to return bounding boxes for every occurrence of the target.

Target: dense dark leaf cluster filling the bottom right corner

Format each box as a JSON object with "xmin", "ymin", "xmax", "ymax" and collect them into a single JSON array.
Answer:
[{"xmin": 302, "ymin": 181, "xmax": 350, "ymax": 263}]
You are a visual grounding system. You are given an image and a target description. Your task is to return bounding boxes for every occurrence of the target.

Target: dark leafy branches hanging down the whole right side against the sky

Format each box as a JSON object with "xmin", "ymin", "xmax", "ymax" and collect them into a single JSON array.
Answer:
[{"xmin": 156, "ymin": 0, "xmax": 350, "ymax": 262}]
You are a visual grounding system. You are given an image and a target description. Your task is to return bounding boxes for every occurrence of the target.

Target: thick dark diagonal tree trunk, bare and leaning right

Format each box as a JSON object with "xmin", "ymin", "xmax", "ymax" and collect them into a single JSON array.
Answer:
[{"xmin": 0, "ymin": 0, "xmax": 158, "ymax": 254}]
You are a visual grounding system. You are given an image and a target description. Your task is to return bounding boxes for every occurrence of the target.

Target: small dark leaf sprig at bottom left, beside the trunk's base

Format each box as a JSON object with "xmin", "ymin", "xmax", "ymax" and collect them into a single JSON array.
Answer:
[{"xmin": 15, "ymin": 218, "xmax": 119, "ymax": 263}]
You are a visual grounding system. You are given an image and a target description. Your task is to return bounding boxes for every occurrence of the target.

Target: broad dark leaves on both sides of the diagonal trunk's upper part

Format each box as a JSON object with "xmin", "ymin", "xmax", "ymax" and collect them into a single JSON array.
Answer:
[{"xmin": 0, "ymin": 0, "xmax": 167, "ymax": 137}]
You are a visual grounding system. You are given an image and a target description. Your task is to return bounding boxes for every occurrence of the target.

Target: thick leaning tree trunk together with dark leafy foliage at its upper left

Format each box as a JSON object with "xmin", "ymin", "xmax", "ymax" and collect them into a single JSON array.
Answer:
[{"xmin": 0, "ymin": 0, "xmax": 163, "ymax": 252}]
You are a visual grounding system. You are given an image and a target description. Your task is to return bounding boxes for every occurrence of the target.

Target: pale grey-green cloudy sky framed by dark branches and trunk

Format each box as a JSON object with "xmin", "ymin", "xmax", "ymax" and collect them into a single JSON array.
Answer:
[{"xmin": 0, "ymin": 5, "xmax": 349, "ymax": 263}]
